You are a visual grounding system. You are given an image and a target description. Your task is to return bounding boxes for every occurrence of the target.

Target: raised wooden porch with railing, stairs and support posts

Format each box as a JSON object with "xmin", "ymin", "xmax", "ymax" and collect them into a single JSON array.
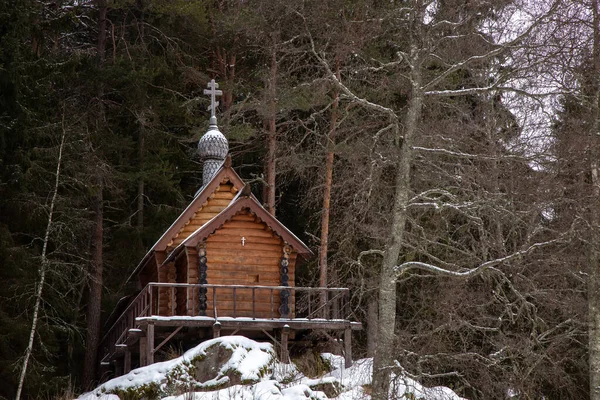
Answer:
[{"xmin": 99, "ymin": 282, "xmax": 362, "ymax": 375}]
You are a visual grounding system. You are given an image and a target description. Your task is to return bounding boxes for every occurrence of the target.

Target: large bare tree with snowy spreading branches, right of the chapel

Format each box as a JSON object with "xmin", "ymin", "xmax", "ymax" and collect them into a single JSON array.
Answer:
[{"xmin": 302, "ymin": 0, "xmax": 558, "ymax": 399}]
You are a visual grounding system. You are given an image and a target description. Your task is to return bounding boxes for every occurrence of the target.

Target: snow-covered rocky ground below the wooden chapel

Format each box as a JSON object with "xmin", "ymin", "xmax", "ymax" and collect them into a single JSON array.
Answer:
[{"xmin": 78, "ymin": 336, "xmax": 464, "ymax": 400}]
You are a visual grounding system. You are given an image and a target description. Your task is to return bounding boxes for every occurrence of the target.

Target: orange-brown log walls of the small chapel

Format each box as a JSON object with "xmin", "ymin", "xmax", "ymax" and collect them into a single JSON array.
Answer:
[{"xmin": 152, "ymin": 179, "xmax": 296, "ymax": 318}]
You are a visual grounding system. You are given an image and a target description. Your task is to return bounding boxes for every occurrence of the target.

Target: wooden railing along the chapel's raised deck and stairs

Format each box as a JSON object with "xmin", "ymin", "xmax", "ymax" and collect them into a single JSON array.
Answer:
[{"xmin": 100, "ymin": 283, "xmax": 350, "ymax": 361}]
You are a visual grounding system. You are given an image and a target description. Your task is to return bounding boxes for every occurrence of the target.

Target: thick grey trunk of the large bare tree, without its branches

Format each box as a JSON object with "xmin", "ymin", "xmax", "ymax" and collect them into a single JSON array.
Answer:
[{"xmin": 373, "ymin": 51, "xmax": 424, "ymax": 400}]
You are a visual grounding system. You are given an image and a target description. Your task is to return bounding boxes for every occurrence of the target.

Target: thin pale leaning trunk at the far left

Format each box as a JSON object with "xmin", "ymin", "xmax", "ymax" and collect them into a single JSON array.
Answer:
[{"xmin": 15, "ymin": 120, "xmax": 66, "ymax": 400}]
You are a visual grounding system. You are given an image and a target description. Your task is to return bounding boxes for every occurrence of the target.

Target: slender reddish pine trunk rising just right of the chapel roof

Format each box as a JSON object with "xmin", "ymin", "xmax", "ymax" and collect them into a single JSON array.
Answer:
[{"xmin": 319, "ymin": 56, "xmax": 341, "ymax": 310}]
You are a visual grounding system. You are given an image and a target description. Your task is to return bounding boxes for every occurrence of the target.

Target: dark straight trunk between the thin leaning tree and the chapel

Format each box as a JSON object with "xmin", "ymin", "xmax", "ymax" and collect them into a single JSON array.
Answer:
[{"xmin": 82, "ymin": 175, "xmax": 104, "ymax": 389}]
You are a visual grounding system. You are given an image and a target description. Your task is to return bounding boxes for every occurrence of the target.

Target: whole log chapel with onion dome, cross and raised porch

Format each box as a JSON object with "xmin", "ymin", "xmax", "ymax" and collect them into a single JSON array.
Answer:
[{"xmin": 99, "ymin": 80, "xmax": 361, "ymax": 375}]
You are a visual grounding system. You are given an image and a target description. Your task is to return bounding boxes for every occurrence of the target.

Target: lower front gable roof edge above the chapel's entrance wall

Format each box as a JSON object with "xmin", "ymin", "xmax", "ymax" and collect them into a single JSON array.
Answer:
[{"xmin": 163, "ymin": 188, "xmax": 313, "ymax": 264}]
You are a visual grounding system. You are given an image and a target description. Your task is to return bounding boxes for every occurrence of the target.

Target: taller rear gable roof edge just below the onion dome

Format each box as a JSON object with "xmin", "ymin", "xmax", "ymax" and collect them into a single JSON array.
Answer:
[{"xmin": 127, "ymin": 156, "xmax": 244, "ymax": 281}]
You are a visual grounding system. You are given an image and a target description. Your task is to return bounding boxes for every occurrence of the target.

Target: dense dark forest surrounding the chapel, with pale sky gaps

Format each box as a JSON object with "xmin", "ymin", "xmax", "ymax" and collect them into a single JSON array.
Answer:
[{"xmin": 0, "ymin": 0, "xmax": 600, "ymax": 399}]
